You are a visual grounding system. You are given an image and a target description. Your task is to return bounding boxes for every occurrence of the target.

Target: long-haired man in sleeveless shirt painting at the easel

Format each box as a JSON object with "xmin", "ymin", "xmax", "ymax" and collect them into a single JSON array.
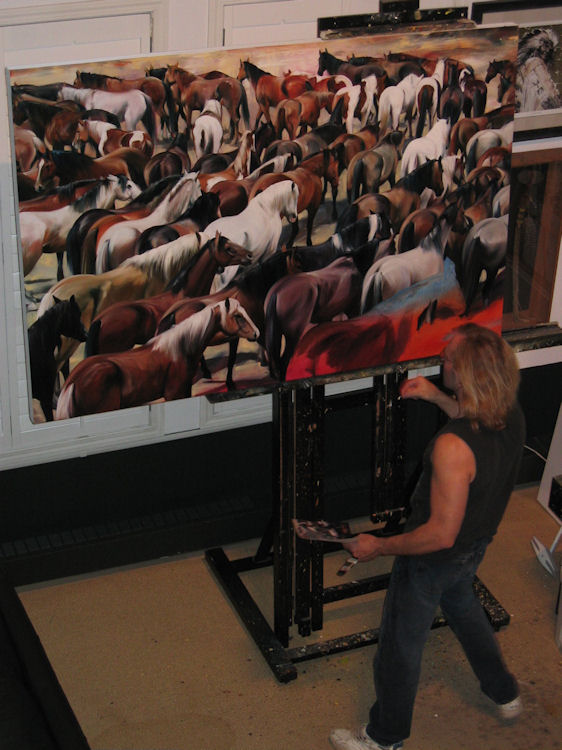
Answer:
[{"xmin": 330, "ymin": 323, "xmax": 525, "ymax": 750}]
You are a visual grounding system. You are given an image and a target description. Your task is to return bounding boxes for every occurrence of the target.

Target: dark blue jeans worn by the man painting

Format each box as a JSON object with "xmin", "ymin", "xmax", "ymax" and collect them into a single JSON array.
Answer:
[{"xmin": 367, "ymin": 539, "xmax": 519, "ymax": 745}]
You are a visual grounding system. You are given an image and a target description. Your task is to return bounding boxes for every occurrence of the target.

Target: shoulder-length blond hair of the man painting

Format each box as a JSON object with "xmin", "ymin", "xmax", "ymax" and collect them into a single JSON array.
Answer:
[{"xmin": 451, "ymin": 323, "xmax": 520, "ymax": 430}]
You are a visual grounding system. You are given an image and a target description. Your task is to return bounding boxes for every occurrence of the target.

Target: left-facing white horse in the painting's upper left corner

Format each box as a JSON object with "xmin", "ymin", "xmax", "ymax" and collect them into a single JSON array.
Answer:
[{"xmin": 58, "ymin": 86, "xmax": 154, "ymax": 138}]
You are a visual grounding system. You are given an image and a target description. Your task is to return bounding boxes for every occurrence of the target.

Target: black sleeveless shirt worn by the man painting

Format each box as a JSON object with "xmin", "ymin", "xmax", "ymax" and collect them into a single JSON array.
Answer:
[{"xmin": 405, "ymin": 405, "xmax": 525, "ymax": 559}]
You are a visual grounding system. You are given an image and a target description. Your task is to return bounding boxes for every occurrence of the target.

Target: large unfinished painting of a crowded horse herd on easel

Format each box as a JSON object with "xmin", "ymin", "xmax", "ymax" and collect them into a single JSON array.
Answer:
[{"xmin": 9, "ymin": 27, "xmax": 517, "ymax": 421}]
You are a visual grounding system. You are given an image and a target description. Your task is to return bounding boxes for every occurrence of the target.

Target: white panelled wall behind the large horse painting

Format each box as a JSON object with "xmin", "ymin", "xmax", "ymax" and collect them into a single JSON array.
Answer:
[{"xmin": 0, "ymin": 0, "xmax": 562, "ymax": 470}]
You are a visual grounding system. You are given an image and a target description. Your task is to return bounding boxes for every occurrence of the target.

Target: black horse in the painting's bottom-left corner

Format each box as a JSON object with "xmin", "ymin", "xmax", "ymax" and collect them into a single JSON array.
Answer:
[{"xmin": 27, "ymin": 297, "xmax": 86, "ymax": 422}]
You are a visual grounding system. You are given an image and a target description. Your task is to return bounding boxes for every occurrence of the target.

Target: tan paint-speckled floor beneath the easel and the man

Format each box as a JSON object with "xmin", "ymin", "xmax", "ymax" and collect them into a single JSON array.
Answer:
[{"xmin": 19, "ymin": 486, "xmax": 562, "ymax": 750}]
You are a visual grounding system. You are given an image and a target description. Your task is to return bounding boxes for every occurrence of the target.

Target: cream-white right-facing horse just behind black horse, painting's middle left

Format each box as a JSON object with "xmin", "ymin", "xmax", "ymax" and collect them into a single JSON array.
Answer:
[{"xmin": 96, "ymin": 172, "xmax": 201, "ymax": 273}]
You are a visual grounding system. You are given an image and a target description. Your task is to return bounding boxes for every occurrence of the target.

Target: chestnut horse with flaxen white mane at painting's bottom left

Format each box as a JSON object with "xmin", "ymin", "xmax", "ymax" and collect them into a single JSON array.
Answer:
[{"xmin": 55, "ymin": 300, "xmax": 259, "ymax": 419}]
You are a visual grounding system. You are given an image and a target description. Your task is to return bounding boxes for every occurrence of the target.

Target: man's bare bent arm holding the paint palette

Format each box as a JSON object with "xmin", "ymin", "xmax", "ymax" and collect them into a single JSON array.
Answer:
[{"xmin": 344, "ymin": 433, "xmax": 476, "ymax": 562}]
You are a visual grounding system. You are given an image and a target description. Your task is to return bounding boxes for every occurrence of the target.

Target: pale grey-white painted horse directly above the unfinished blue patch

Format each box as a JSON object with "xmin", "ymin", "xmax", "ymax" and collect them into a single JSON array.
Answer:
[{"xmin": 361, "ymin": 213, "xmax": 451, "ymax": 313}]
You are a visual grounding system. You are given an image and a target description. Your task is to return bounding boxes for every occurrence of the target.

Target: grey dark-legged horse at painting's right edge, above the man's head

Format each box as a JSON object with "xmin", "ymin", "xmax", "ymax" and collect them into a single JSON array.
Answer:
[{"xmin": 459, "ymin": 215, "xmax": 509, "ymax": 315}]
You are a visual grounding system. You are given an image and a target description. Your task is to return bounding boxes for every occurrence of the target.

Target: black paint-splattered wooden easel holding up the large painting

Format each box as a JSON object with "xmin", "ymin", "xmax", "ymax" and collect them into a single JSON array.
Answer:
[{"xmin": 205, "ymin": 362, "xmax": 509, "ymax": 682}]
